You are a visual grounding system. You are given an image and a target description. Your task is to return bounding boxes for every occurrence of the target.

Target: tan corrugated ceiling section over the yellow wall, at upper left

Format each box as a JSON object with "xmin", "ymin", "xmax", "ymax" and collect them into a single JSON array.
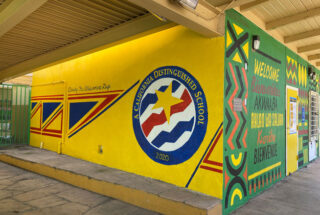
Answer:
[{"xmin": 0, "ymin": 0, "xmax": 165, "ymax": 80}]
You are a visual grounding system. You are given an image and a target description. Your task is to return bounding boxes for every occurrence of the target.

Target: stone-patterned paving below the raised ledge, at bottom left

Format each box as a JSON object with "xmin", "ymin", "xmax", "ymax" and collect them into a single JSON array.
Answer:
[{"xmin": 0, "ymin": 162, "xmax": 157, "ymax": 215}]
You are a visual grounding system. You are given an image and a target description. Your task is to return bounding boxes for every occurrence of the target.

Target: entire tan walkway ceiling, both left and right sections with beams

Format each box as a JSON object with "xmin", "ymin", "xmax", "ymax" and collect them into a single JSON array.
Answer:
[{"xmin": 0, "ymin": 0, "xmax": 320, "ymax": 80}]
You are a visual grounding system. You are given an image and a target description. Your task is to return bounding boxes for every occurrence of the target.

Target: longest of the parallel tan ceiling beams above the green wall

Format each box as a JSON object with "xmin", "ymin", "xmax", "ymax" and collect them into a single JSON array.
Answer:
[{"xmin": 266, "ymin": 7, "xmax": 320, "ymax": 30}]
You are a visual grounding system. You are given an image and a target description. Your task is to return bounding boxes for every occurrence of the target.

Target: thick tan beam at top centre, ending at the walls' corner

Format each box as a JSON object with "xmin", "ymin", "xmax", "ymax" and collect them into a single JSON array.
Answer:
[{"xmin": 129, "ymin": 0, "xmax": 225, "ymax": 37}]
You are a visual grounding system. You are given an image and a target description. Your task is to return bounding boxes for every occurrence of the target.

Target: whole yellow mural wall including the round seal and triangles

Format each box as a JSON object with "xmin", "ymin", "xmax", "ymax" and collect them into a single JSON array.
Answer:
[{"xmin": 30, "ymin": 26, "xmax": 225, "ymax": 199}]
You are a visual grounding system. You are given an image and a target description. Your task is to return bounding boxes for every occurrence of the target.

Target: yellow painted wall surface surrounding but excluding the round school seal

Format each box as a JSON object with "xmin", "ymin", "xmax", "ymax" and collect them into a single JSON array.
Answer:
[{"xmin": 30, "ymin": 26, "xmax": 224, "ymax": 198}]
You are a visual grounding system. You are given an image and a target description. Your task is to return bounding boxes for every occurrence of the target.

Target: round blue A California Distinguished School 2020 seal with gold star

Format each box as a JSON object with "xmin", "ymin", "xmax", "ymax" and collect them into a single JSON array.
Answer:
[{"xmin": 132, "ymin": 66, "xmax": 208, "ymax": 165}]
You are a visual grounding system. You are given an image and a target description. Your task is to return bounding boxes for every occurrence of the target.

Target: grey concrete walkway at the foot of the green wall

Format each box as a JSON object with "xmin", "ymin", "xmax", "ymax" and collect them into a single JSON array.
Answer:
[{"xmin": 233, "ymin": 159, "xmax": 320, "ymax": 215}]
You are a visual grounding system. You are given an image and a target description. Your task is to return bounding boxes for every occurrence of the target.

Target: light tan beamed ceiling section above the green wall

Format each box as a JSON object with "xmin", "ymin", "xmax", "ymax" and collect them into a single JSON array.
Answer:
[{"xmin": 235, "ymin": 0, "xmax": 320, "ymax": 67}]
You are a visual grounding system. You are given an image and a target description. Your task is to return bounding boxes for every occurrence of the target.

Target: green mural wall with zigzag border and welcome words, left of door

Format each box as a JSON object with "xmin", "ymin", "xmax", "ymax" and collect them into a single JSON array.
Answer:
[{"xmin": 223, "ymin": 10, "xmax": 285, "ymax": 214}]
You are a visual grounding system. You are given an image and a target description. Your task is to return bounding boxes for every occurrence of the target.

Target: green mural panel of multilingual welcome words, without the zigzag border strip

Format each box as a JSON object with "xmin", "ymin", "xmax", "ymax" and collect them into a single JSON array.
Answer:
[{"xmin": 248, "ymin": 25, "xmax": 286, "ymax": 197}]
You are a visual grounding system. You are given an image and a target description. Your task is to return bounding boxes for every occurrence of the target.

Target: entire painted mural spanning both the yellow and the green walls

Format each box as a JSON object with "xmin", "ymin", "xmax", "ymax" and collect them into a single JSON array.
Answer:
[{"xmin": 30, "ymin": 10, "xmax": 319, "ymax": 214}]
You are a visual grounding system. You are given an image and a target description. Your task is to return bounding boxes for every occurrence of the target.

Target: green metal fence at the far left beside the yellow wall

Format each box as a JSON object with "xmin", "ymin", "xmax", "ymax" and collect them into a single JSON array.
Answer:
[{"xmin": 0, "ymin": 84, "xmax": 31, "ymax": 146}]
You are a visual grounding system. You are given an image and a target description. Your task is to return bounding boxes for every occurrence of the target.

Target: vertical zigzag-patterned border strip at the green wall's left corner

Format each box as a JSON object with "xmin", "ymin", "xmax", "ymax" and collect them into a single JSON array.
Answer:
[{"xmin": 223, "ymin": 20, "xmax": 250, "ymax": 213}]
